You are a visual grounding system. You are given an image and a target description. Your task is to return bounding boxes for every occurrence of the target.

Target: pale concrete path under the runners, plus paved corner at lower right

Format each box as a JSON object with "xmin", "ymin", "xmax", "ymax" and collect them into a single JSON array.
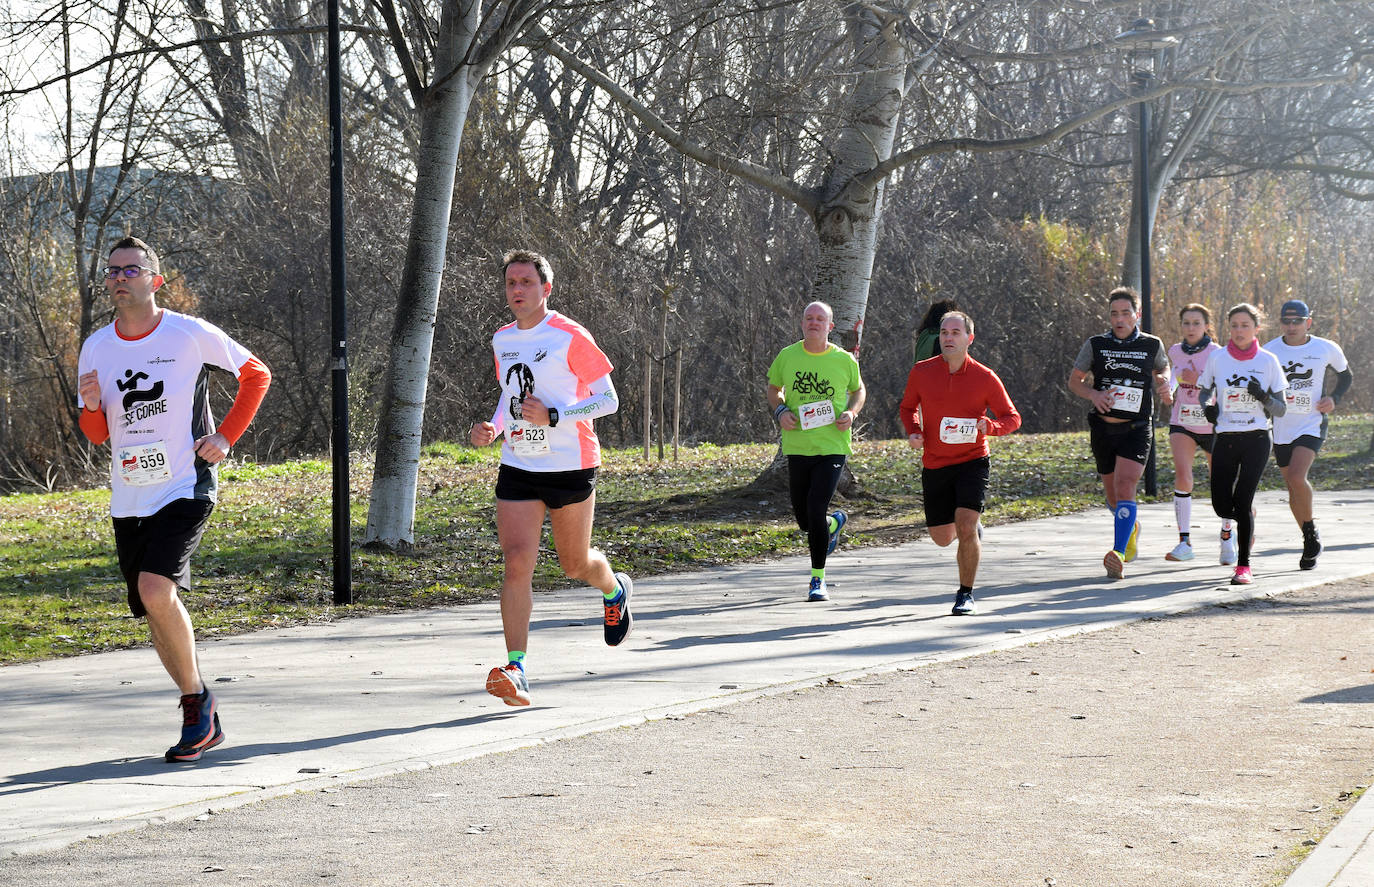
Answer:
[{"xmin": 0, "ymin": 492, "xmax": 1374, "ymax": 887}]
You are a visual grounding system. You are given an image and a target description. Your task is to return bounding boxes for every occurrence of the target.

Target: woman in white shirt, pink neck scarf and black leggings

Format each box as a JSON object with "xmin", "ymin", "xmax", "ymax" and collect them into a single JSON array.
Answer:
[{"xmin": 1198, "ymin": 302, "xmax": 1287, "ymax": 585}]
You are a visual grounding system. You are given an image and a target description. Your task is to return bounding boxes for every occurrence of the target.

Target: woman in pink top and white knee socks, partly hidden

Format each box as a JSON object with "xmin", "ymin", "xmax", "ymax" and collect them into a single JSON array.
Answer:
[{"xmin": 1164, "ymin": 302, "xmax": 1235, "ymax": 564}]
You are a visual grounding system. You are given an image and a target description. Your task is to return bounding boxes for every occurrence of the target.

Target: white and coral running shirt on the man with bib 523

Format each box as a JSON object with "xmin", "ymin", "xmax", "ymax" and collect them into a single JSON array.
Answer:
[{"xmin": 492, "ymin": 312, "xmax": 613, "ymax": 471}]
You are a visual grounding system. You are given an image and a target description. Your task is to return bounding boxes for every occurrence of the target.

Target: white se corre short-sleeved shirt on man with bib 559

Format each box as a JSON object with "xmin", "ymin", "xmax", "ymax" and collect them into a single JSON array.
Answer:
[{"xmin": 77, "ymin": 309, "xmax": 253, "ymax": 518}]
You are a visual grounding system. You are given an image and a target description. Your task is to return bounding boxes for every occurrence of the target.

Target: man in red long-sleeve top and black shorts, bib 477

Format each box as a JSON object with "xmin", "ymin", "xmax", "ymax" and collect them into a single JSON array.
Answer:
[{"xmin": 897, "ymin": 312, "xmax": 1021, "ymax": 617}]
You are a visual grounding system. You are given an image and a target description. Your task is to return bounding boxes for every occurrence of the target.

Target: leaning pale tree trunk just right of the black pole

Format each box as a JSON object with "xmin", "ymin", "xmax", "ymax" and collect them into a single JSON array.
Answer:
[{"xmin": 363, "ymin": 4, "xmax": 480, "ymax": 549}]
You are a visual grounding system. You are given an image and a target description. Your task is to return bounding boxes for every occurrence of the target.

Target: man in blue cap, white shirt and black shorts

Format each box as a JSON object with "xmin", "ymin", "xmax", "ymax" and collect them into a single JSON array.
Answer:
[{"xmin": 1264, "ymin": 299, "xmax": 1353, "ymax": 570}]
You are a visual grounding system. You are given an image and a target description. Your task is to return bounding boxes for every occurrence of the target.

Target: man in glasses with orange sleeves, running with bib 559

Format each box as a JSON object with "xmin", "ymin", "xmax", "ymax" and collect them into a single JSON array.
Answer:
[{"xmin": 77, "ymin": 238, "xmax": 272, "ymax": 762}]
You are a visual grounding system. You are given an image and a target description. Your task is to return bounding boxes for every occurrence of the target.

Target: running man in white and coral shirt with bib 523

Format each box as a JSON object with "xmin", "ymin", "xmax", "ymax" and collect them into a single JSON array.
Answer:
[{"xmin": 470, "ymin": 250, "xmax": 633, "ymax": 706}]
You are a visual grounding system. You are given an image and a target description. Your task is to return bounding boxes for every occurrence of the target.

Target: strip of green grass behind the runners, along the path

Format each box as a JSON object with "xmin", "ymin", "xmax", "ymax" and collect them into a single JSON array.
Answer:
[{"xmin": 0, "ymin": 416, "xmax": 1374, "ymax": 662}]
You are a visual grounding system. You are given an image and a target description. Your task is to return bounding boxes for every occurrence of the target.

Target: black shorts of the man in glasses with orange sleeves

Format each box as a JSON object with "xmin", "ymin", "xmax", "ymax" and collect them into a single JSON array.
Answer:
[{"xmin": 113, "ymin": 498, "xmax": 214, "ymax": 618}]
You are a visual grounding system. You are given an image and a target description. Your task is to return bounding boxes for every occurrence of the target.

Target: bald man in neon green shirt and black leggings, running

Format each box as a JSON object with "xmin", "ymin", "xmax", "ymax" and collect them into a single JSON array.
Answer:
[{"xmin": 768, "ymin": 302, "xmax": 864, "ymax": 600}]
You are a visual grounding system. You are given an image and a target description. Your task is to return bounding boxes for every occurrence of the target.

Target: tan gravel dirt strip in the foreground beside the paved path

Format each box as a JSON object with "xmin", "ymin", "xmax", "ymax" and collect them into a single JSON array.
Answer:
[{"xmin": 0, "ymin": 577, "xmax": 1374, "ymax": 887}]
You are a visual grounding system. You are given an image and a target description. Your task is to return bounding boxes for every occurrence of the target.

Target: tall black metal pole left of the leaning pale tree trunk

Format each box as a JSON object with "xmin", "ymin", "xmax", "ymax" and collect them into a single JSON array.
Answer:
[{"xmin": 328, "ymin": 0, "xmax": 353, "ymax": 604}]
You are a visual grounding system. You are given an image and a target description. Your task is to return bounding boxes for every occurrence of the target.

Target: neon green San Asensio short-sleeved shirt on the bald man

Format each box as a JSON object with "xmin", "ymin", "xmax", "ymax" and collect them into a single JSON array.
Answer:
[{"xmin": 768, "ymin": 342, "xmax": 863, "ymax": 456}]
